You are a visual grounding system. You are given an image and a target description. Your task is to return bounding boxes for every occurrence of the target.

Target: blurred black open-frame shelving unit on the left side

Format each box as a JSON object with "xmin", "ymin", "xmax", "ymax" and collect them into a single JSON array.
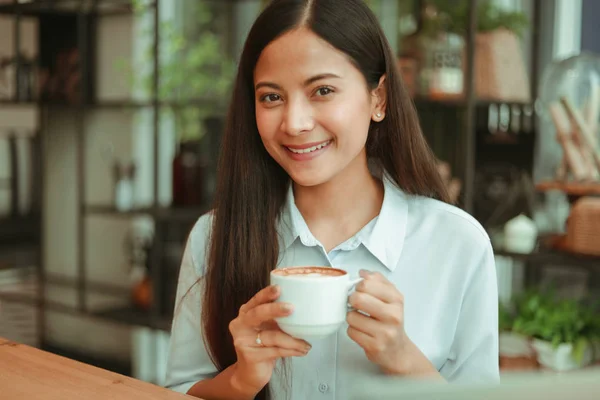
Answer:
[{"xmin": 0, "ymin": 0, "xmax": 199, "ymax": 352}]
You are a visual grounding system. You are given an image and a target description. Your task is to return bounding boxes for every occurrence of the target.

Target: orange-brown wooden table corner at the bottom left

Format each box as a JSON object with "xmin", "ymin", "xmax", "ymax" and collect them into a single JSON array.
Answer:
[{"xmin": 0, "ymin": 338, "xmax": 192, "ymax": 400}]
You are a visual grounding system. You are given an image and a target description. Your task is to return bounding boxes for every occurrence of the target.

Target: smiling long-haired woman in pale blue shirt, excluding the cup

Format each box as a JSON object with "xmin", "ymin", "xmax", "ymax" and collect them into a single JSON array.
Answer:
[{"xmin": 167, "ymin": 0, "xmax": 498, "ymax": 399}]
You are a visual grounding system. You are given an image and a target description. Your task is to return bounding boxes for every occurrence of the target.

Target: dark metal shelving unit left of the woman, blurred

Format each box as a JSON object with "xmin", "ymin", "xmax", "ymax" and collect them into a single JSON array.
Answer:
[{"xmin": 0, "ymin": 0, "xmax": 237, "ymax": 364}]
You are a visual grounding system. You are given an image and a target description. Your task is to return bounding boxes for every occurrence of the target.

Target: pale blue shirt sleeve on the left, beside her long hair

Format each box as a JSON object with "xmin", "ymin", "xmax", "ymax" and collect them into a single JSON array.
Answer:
[{"xmin": 165, "ymin": 216, "xmax": 217, "ymax": 393}]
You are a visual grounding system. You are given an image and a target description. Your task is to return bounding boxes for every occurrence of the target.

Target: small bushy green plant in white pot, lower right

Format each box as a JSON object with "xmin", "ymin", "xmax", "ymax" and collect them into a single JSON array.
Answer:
[{"xmin": 513, "ymin": 292, "xmax": 598, "ymax": 371}]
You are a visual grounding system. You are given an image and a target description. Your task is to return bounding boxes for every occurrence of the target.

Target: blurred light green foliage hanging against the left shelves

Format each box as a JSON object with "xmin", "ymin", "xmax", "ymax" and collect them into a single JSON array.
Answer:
[{"xmin": 120, "ymin": 0, "xmax": 235, "ymax": 140}]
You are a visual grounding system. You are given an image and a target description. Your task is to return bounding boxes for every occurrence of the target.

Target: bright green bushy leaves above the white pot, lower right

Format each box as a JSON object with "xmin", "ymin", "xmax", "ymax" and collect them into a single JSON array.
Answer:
[{"xmin": 512, "ymin": 290, "xmax": 600, "ymax": 361}]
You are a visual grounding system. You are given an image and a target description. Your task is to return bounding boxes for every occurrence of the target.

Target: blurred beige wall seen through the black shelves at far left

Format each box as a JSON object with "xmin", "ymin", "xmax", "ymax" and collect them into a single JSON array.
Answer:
[{"xmin": 43, "ymin": 16, "xmax": 134, "ymax": 360}]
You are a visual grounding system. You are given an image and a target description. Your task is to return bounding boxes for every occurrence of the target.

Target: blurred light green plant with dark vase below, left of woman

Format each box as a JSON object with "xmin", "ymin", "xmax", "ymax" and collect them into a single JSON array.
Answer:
[{"xmin": 120, "ymin": 0, "xmax": 235, "ymax": 206}]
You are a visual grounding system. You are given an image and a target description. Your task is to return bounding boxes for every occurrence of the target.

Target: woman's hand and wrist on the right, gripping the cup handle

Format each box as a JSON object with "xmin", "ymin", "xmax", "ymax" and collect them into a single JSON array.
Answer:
[{"xmin": 347, "ymin": 271, "xmax": 439, "ymax": 376}]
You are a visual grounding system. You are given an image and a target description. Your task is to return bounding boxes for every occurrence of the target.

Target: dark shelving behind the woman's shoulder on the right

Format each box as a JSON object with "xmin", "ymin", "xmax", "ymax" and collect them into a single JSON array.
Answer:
[{"xmin": 414, "ymin": 0, "xmax": 600, "ymax": 283}]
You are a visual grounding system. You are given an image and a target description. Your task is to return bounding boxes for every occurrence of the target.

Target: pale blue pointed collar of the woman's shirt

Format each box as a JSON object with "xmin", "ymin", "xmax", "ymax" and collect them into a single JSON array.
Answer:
[{"xmin": 278, "ymin": 174, "xmax": 408, "ymax": 271}]
